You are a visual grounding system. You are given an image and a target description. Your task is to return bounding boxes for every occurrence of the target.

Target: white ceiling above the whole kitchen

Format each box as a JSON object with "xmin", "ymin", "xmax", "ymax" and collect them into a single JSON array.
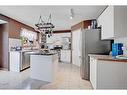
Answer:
[{"xmin": 0, "ymin": 5, "xmax": 106, "ymax": 30}]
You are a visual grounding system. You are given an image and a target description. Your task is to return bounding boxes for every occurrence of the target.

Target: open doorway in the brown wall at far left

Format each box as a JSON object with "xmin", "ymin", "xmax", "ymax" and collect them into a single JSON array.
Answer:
[{"xmin": 0, "ymin": 20, "xmax": 8, "ymax": 70}]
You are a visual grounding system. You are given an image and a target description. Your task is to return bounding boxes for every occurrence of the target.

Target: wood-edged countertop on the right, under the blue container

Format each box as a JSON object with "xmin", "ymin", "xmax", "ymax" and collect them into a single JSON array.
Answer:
[{"xmin": 88, "ymin": 54, "xmax": 127, "ymax": 62}]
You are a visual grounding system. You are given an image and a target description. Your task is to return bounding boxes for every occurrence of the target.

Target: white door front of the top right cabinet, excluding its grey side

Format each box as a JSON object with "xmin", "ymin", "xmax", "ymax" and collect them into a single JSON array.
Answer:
[{"xmin": 98, "ymin": 6, "xmax": 114, "ymax": 39}]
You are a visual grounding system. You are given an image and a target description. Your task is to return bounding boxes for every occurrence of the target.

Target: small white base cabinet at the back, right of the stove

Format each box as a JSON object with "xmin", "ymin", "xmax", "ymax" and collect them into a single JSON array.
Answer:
[{"xmin": 60, "ymin": 50, "xmax": 71, "ymax": 63}]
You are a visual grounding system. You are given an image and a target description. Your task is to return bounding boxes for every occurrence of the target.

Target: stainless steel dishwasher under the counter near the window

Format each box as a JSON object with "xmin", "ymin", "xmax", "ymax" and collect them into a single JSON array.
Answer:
[{"xmin": 20, "ymin": 52, "xmax": 30, "ymax": 71}]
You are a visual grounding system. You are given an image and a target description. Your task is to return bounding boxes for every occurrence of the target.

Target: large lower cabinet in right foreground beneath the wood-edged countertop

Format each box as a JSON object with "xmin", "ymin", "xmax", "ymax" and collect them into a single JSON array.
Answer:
[{"xmin": 90, "ymin": 57, "xmax": 127, "ymax": 89}]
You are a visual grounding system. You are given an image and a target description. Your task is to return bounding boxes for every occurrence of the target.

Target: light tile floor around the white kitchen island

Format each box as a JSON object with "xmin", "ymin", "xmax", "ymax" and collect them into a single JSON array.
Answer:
[{"xmin": 0, "ymin": 63, "xmax": 92, "ymax": 89}]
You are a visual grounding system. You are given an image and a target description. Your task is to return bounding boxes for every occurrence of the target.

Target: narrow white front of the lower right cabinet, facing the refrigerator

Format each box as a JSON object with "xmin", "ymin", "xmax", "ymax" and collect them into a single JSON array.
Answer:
[{"xmin": 90, "ymin": 57, "xmax": 97, "ymax": 89}]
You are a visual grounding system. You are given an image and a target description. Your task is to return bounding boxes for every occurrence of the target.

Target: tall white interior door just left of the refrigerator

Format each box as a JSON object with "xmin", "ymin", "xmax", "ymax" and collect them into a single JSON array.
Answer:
[{"xmin": 72, "ymin": 29, "xmax": 82, "ymax": 67}]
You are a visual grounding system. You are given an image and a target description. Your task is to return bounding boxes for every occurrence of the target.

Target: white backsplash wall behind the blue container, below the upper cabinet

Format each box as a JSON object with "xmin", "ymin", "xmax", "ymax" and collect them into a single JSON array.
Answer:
[{"xmin": 114, "ymin": 37, "xmax": 127, "ymax": 55}]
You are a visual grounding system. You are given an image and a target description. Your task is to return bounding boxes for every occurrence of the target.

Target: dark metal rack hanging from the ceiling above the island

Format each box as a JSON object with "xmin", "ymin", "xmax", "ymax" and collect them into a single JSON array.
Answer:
[{"xmin": 35, "ymin": 14, "xmax": 55, "ymax": 37}]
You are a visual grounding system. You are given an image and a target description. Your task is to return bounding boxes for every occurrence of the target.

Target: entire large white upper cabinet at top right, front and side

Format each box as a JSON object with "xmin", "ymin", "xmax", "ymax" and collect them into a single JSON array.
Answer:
[{"xmin": 97, "ymin": 6, "xmax": 127, "ymax": 39}]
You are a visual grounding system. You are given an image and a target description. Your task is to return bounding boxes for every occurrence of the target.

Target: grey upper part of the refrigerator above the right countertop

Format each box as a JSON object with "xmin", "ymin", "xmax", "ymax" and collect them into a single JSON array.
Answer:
[{"xmin": 84, "ymin": 29, "xmax": 111, "ymax": 55}]
